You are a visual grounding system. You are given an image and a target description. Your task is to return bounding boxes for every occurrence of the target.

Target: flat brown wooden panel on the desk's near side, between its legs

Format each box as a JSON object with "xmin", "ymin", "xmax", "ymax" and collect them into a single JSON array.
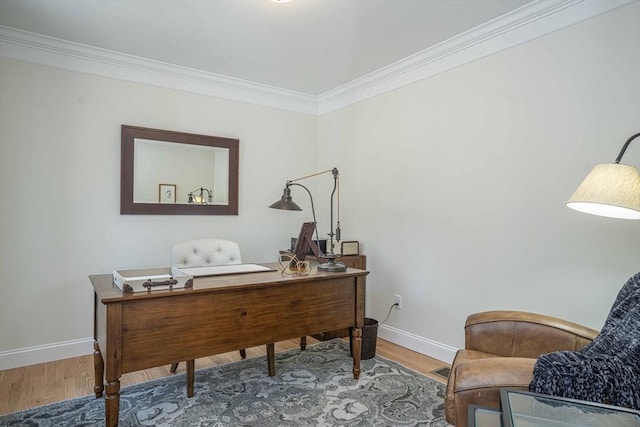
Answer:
[{"xmin": 121, "ymin": 277, "xmax": 358, "ymax": 372}]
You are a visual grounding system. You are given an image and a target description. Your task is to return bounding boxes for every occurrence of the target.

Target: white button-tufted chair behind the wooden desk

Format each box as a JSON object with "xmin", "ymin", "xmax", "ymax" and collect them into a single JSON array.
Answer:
[{"xmin": 170, "ymin": 239, "xmax": 247, "ymax": 372}]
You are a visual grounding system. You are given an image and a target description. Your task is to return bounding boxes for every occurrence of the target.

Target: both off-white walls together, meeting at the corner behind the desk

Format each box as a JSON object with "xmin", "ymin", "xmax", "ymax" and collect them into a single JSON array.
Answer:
[{"xmin": 0, "ymin": 2, "xmax": 640, "ymax": 369}]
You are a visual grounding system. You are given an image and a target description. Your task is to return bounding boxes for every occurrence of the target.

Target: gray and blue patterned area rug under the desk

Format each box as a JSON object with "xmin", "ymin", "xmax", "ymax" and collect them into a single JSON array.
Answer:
[{"xmin": 0, "ymin": 339, "xmax": 448, "ymax": 427}]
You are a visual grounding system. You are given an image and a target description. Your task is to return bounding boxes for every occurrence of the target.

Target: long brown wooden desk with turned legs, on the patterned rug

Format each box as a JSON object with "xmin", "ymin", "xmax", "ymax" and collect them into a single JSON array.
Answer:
[{"xmin": 89, "ymin": 264, "xmax": 368, "ymax": 427}]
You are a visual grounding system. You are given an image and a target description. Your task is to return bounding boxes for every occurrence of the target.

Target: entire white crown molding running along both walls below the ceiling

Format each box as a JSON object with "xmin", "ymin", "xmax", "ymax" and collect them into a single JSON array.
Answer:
[{"xmin": 0, "ymin": 0, "xmax": 638, "ymax": 115}]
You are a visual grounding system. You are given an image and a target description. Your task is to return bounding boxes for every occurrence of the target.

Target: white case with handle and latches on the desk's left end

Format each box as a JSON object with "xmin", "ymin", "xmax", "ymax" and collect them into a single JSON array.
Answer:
[{"xmin": 113, "ymin": 267, "xmax": 193, "ymax": 294}]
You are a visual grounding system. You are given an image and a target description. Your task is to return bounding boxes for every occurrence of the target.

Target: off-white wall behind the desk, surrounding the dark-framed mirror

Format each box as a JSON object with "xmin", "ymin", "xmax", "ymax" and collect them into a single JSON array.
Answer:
[{"xmin": 0, "ymin": 59, "xmax": 318, "ymax": 368}]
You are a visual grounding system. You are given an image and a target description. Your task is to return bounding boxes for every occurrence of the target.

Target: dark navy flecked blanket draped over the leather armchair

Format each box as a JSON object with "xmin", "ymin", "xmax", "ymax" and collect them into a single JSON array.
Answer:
[{"xmin": 529, "ymin": 273, "xmax": 640, "ymax": 409}]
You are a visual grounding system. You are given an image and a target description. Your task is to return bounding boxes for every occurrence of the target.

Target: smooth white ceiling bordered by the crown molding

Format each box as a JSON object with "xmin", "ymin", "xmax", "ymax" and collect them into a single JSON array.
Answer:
[{"xmin": 0, "ymin": 0, "xmax": 531, "ymax": 95}]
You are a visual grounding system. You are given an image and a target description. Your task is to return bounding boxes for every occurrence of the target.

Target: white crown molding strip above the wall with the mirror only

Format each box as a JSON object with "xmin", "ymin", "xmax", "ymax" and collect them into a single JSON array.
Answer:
[{"xmin": 0, "ymin": 26, "xmax": 318, "ymax": 115}]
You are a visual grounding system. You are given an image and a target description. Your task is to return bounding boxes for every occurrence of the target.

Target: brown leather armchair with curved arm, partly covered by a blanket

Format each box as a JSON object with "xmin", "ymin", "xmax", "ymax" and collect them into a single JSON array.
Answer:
[{"xmin": 445, "ymin": 311, "xmax": 599, "ymax": 427}]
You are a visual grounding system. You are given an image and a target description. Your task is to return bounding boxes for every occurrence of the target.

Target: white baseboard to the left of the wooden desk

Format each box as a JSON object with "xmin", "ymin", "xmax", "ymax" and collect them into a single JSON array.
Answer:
[{"xmin": 0, "ymin": 338, "xmax": 93, "ymax": 370}]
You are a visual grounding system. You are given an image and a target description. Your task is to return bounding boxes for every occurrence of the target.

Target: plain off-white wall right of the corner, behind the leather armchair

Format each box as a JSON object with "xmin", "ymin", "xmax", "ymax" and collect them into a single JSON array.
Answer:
[{"xmin": 319, "ymin": 2, "xmax": 640, "ymax": 357}]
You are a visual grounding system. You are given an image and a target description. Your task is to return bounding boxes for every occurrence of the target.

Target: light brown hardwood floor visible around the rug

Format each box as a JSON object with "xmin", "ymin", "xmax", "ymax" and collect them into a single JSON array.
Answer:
[{"xmin": 0, "ymin": 337, "xmax": 448, "ymax": 415}]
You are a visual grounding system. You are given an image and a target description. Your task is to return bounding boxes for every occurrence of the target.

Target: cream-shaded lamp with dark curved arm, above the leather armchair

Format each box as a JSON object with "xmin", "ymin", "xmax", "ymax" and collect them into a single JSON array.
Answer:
[{"xmin": 567, "ymin": 133, "xmax": 640, "ymax": 219}]
